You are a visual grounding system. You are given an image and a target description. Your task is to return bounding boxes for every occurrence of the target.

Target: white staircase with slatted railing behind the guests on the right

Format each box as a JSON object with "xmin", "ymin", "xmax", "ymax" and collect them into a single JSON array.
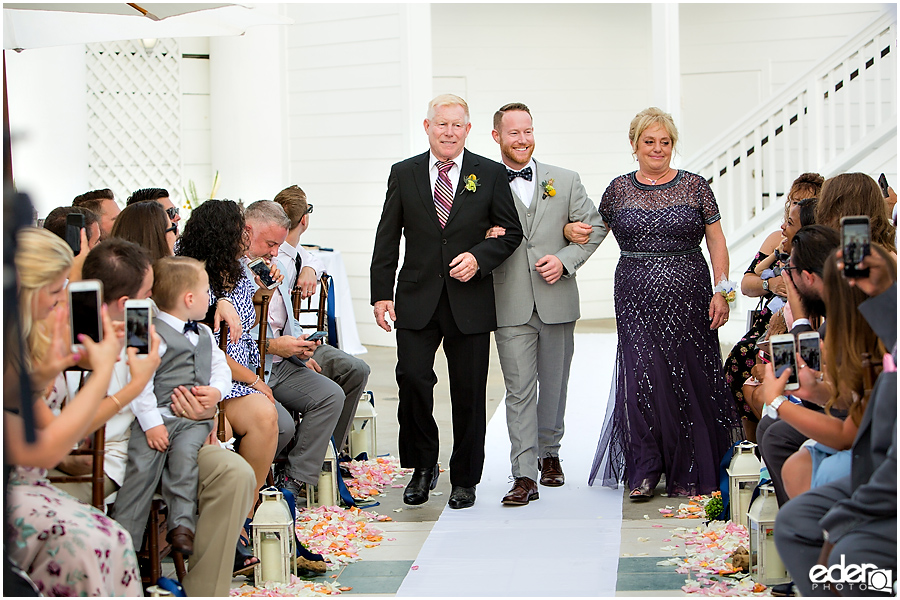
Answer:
[{"xmin": 682, "ymin": 11, "xmax": 900, "ymax": 346}]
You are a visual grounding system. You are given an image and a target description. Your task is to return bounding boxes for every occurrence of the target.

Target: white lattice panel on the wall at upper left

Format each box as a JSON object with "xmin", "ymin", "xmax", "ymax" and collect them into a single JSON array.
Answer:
[{"xmin": 85, "ymin": 39, "xmax": 183, "ymax": 206}]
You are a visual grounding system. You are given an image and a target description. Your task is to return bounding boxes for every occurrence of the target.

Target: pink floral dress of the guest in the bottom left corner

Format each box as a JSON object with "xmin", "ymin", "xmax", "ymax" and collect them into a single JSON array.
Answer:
[{"xmin": 6, "ymin": 390, "xmax": 143, "ymax": 596}]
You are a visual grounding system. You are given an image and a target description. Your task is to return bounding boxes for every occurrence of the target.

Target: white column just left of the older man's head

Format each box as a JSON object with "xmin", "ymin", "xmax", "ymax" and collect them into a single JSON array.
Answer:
[{"xmin": 400, "ymin": 3, "xmax": 433, "ymax": 156}]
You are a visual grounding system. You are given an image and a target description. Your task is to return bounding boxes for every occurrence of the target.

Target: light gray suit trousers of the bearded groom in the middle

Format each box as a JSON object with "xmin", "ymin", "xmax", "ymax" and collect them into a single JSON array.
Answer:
[{"xmin": 494, "ymin": 311, "xmax": 575, "ymax": 481}]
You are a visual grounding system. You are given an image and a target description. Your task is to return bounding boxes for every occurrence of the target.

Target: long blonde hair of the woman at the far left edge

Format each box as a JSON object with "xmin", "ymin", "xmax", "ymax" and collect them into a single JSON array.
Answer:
[{"xmin": 15, "ymin": 227, "xmax": 75, "ymax": 364}]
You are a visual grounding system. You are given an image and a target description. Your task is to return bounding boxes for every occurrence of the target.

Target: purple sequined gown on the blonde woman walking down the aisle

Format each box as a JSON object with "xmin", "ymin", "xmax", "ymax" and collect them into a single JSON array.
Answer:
[{"xmin": 589, "ymin": 171, "xmax": 740, "ymax": 495}]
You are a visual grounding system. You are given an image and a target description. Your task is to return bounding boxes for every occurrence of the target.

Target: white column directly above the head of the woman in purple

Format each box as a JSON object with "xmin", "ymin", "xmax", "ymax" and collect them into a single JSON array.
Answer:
[{"xmin": 650, "ymin": 3, "xmax": 681, "ymax": 125}]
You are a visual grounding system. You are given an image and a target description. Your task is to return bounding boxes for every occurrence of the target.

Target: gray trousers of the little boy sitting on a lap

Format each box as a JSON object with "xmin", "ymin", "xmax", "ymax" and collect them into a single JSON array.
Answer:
[{"xmin": 113, "ymin": 417, "xmax": 213, "ymax": 550}]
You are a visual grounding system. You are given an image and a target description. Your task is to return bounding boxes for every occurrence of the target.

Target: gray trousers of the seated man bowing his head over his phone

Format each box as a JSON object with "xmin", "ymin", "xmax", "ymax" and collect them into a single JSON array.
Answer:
[{"xmin": 268, "ymin": 360, "xmax": 344, "ymax": 485}]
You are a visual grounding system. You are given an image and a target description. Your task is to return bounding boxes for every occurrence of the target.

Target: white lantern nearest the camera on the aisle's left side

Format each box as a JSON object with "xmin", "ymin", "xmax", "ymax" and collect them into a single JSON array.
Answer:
[{"xmin": 251, "ymin": 488, "xmax": 297, "ymax": 583}]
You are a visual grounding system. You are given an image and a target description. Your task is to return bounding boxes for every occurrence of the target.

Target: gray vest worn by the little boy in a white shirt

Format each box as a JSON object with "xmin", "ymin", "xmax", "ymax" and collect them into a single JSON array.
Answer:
[{"xmin": 153, "ymin": 318, "xmax": 212, "ymax": 406}]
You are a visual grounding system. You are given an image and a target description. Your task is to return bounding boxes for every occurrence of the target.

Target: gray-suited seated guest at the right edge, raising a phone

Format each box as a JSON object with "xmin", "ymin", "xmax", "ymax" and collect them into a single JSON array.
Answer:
[{"xmin": 763, "ymin": 246, "xmax": 897, "ymax": 596}]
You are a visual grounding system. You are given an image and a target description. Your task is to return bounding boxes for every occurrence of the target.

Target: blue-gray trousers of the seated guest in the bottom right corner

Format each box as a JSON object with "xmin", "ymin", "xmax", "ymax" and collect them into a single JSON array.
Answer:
[{"xmin": 775, "ymin": 475, "xmax": 897, "ymax": 596}]
